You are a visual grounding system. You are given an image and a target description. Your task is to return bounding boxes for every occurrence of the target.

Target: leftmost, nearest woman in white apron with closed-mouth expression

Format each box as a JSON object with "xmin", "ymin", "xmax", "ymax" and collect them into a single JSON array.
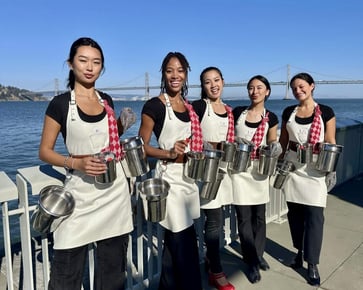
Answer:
[{"xmin": 39, "ymin": 38, "xmax": 133, "ymax": 290}]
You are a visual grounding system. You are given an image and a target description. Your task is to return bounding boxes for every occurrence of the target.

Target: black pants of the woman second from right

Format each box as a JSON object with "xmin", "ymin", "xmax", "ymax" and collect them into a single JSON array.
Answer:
[{"xmin": 235, "ymin": 204, "xmax": 266, "ymax": 265}]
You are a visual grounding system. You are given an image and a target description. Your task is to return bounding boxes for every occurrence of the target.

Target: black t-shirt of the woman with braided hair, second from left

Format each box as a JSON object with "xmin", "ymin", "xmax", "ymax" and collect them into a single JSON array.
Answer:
[{"xmin": 141, "ymin": 97, "xmax": 190, "ymax": 139}]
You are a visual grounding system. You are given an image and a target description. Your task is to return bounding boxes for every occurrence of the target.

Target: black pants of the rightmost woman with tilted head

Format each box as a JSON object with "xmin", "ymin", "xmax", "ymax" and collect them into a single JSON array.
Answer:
[{"xmin": 287, "ymin": 202, "xmax": 324, "ymax": 264}]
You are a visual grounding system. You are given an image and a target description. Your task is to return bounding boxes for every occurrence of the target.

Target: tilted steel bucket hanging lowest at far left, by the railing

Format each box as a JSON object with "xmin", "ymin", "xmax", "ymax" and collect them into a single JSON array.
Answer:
[{"xmin": 31, "ymin": 185, "xmax": 75, "ymax": 233}]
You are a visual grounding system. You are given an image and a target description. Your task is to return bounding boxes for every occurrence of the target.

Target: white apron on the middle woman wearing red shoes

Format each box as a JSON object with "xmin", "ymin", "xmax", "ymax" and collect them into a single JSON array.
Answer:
[{"xmin": 200, "ymin": 101, "xmax": 233, "ymax": 209}]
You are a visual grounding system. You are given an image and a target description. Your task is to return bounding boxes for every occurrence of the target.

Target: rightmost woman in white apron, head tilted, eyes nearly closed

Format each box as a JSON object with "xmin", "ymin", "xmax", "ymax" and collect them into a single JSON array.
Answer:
[{"xmin": 280, "ymin": 73, "xmax": 336, "ymax": 286}]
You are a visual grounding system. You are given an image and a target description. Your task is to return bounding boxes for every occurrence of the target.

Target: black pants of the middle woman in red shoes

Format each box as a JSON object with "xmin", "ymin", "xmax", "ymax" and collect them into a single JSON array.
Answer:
[{"xmin": 204, "ymin": 208, "xmax": 223, "ymax": 273}]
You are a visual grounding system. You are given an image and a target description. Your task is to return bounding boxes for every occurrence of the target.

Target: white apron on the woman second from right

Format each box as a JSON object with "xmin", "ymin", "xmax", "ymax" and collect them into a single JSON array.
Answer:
[{"xmin": 231, "ymin": 110, "xmax": 270, "ymax": 205}]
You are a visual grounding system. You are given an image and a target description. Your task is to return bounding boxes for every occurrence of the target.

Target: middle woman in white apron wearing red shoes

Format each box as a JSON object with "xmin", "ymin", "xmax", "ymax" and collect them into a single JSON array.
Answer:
[{"xmin": 192, "ymin": 67, "xmax": 235, "ymax": 290}]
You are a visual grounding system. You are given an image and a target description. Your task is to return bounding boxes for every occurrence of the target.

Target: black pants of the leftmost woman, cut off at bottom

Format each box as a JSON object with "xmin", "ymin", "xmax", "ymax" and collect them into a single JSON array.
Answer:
[{"xmin": 48, "ymin": 234, "xmax": 129, "ymax": 290}]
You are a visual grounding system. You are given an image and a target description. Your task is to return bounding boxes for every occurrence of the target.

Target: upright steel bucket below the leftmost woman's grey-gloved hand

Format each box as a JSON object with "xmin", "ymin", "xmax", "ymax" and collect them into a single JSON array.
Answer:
[{"xmin": 120, "ymin": 136, "xmax": 150, "ymax": 177}]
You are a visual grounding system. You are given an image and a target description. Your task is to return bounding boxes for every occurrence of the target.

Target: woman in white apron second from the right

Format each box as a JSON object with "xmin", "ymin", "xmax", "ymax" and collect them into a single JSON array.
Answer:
[{"xmin": 231, "ymin": 75, "xmax": 278, "ymax": 283}]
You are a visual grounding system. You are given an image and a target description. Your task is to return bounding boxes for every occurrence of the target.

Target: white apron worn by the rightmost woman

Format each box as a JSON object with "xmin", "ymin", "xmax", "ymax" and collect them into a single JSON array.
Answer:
[{"xmin": 282, "ymin": 108, "xmax": 327, "ymax": 207}]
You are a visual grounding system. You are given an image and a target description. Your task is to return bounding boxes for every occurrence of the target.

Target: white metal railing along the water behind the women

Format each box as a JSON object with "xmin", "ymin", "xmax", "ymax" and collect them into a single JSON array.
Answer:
[{"xmin": 0, "ymin": 124, "xmax": 363, "ymax": 290}]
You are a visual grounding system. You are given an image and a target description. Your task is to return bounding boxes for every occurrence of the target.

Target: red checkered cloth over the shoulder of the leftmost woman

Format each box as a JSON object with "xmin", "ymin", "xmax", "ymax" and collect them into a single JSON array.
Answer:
[{"xmin": 102, "ymin": 100, "xmax": 125, "ymax": 160}]
